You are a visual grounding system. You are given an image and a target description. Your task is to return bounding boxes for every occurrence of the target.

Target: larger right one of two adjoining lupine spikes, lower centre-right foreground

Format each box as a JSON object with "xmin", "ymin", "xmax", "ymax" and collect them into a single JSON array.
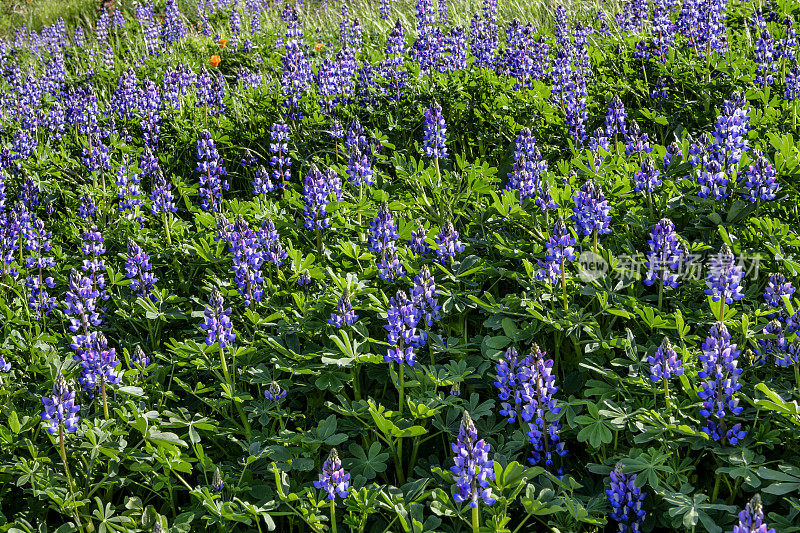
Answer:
[{"xmin": 517, "ymin": 344, "xmax": 567, "ymax": 467}]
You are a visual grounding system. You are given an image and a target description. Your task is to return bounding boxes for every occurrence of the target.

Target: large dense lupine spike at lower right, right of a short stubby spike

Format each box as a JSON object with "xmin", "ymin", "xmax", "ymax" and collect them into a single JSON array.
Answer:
[{"xmin": 697, "ymin": 322, "xmax": 746, "ymax": 446}]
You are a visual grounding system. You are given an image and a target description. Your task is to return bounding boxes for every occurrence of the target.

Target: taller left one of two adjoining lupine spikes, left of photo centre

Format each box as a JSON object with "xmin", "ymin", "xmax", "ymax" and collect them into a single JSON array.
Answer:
[{"xmin": 227, "ymin": 215, "xmax": 264, "ymax": 305}]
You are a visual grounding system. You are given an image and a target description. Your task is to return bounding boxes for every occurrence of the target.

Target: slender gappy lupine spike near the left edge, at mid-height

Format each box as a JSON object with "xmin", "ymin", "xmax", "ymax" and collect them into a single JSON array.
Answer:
[{"xmin": 25, "ymin": 218, "xmax": 56, "ymax": 318}]
